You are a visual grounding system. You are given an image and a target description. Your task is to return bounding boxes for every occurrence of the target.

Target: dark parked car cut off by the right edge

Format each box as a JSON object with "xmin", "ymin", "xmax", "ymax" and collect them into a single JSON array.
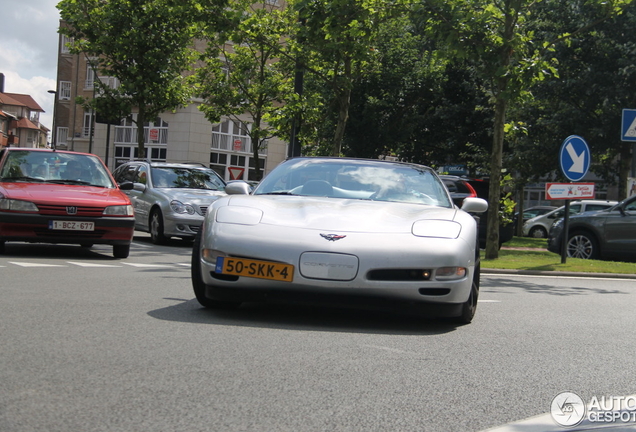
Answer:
[{"xmin": 548, "ymin": 196, "xmax": 636, "ymax": 261}]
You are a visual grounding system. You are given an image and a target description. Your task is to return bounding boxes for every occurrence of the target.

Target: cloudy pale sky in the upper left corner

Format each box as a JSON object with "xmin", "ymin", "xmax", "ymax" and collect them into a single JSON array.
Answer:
[{"xmin": 0, "ymin": 0, "xmax": 60, "ymax": 134}]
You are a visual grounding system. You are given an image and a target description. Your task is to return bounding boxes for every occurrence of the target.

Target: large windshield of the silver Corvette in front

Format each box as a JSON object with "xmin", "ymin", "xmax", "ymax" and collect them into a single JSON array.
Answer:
[{"xmin": 254, "ymin": 158, "xmax": 453, "ymax": 207}]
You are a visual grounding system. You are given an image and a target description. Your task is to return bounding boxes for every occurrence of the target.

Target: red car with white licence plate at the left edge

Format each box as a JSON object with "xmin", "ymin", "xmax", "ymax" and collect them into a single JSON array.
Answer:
[{"xmin": 0, "ymin": 147, "xmax": 135, "ymax": 258}]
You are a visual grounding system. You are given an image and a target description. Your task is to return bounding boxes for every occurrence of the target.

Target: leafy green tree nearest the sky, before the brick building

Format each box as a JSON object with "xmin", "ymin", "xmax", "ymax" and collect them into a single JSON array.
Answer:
[{"xmin": 57, "ymin": 0, "xmax": 225, "ymax": 158}]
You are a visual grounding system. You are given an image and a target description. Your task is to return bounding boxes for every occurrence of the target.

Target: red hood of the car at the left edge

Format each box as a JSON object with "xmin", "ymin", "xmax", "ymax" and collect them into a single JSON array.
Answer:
[{"xmin": 0, "ymin": 183, "xmax": 130, "ymax": 205}]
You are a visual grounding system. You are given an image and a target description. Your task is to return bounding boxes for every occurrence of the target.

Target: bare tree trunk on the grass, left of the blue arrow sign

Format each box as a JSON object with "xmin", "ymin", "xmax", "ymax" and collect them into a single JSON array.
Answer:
[{"xmin": 486, "ymin": 96, "xmax": 507, "ymax": 259}]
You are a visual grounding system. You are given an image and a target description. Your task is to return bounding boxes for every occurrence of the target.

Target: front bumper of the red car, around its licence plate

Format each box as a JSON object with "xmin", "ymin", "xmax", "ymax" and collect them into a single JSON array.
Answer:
[{"xmin": 0, "ymin": 213, "xmax": 135, "ymax": 245}]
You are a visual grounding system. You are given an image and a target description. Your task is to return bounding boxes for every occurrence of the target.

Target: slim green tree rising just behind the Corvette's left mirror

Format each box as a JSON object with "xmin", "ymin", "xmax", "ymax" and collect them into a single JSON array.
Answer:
[{"xmin": 197, "ymin": 1, "xmax": 293, "ymax": 180}]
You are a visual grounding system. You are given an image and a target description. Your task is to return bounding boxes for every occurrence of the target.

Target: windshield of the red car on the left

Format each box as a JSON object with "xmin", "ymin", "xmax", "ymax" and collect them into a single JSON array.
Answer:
[{"xmin": 0, "ymin": 150, "xmax": 115, "ymax": 188}]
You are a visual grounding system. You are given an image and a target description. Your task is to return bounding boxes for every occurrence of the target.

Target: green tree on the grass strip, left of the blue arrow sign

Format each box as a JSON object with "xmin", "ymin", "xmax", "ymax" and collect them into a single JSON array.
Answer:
[{"xmin": 422, "ymin": 0, "xmax": 631, "ymax": 259}]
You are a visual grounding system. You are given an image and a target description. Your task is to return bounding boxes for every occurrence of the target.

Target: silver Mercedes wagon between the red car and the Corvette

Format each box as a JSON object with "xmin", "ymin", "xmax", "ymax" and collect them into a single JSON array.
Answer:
[{"xmin": 113, "ymin": 161, "xmax": 225, "ymax": 244}]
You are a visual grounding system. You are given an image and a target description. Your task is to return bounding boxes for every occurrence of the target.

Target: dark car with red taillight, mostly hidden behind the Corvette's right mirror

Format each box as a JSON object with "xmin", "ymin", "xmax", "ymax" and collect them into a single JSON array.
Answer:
[{"xmin": 439, "ymin": 175, "xmax": 514, "ymax": 249}]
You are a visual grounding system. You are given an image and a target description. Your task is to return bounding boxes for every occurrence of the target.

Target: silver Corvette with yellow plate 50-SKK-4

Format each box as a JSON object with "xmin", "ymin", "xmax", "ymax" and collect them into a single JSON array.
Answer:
[{"xmin": 192, "ymin": 158, "xmax": 488, "ymax": 323}]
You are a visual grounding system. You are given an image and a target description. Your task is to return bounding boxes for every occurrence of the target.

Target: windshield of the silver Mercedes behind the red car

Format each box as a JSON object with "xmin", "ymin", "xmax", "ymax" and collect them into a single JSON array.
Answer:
[{"xmin": 150, "ymin": 167, "xmax": 225, "ymax": 190}]
